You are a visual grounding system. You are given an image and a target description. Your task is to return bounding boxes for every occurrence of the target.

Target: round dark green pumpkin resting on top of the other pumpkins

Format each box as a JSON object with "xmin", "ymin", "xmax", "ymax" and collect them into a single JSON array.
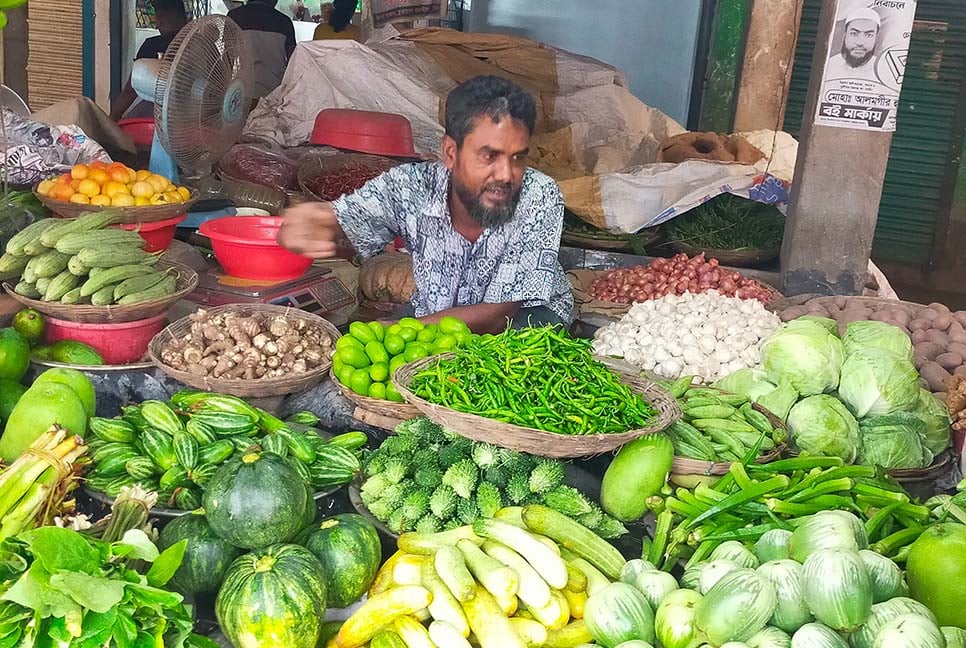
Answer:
[{"xmin": 202, "ymin": 452, "xmax": 315, "ymax": 549}]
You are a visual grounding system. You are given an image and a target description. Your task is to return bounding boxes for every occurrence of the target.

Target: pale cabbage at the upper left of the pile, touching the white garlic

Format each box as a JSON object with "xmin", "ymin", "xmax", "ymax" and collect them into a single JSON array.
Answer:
[{"xmin": 761, "ymin": 320, "xmax": 844, "ymax": 396}]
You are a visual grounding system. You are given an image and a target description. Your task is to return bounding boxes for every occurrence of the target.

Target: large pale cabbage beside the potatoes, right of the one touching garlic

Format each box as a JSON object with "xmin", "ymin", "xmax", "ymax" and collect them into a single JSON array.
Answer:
[{"xmin": 839, "ymin": 349, "xmax": 920, "ymax": 418}]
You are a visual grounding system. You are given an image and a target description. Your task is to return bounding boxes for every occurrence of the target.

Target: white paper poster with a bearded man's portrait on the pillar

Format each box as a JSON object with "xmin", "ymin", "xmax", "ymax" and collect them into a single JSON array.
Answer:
[{"xmin": 815, "ymin": 0, "xmax": 916, "ymax": 132}]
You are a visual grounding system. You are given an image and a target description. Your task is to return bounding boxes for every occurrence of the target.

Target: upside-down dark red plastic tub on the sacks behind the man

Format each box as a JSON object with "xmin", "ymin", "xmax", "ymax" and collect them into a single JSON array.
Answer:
[{"xmin": 309, "ymin": 108, "xmax": 417, "ymax": 157}]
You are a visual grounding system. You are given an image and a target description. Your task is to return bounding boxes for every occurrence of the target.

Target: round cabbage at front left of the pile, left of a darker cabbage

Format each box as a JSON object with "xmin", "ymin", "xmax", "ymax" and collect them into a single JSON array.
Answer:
[{"xmin": 787, "ymin": 394, "xmax": 862, "ymax": 463}]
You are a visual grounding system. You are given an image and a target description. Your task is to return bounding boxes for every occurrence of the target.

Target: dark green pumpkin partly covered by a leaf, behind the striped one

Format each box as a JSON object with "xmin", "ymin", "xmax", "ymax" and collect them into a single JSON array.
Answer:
[{"xmin": 158, "ymin": 511, "xmax": 241, "ymax": 594}]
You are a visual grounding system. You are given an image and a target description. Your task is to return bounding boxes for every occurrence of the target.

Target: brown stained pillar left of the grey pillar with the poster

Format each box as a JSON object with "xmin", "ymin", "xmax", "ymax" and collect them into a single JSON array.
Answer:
[{"xmin": 734, "ymin": 0, "xmax": 804, "ymax": 132}]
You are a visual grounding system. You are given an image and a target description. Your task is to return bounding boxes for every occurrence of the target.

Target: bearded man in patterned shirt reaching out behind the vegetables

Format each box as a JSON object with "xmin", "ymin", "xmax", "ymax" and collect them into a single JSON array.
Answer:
[{"xmin": 278, "ymin": 76, "xmax": 574, "ymax": 333}]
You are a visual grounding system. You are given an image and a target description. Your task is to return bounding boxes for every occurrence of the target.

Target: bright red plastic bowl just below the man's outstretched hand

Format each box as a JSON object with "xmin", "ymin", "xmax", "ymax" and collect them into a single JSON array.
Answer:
[{"xmin": 198, "ymin": 216, "xmax": 312, "ymax": 281}]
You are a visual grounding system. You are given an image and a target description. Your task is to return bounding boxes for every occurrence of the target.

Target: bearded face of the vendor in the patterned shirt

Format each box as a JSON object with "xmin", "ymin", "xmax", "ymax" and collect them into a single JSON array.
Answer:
[{"xmin": 443, "ymin": 116, "xmax": 530, "ymax": 227}]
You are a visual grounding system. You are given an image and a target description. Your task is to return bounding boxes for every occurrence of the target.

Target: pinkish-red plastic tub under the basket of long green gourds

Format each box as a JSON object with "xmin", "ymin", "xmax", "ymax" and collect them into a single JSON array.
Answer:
[{"xmin": 44, "ymin": 313, "xmax": 167, "ymax": 365}]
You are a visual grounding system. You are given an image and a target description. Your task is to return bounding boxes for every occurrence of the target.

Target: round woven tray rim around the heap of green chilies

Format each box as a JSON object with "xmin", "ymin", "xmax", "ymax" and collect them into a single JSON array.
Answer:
[{"xmin": 392, "ymin": 353, "xmax": 681, "ymax": 459}]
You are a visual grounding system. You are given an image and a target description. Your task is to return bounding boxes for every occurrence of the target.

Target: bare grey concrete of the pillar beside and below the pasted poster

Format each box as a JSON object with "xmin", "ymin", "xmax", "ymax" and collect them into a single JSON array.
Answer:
[{"xmin": 781, "ymin": 0, "xmax": 904, "ymax": 295}]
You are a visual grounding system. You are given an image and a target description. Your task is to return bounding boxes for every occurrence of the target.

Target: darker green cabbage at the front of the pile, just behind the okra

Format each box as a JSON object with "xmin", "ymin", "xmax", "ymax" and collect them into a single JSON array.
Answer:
[{"xmin": 859, "ymin": 412, "xmax": 932, "ymax": 468}]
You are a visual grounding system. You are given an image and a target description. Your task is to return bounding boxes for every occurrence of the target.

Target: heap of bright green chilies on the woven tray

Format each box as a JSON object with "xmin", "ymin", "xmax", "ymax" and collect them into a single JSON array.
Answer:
[{"xmin": 410, "ymin": 326, "xmax": 656, "ymax": 435}]
